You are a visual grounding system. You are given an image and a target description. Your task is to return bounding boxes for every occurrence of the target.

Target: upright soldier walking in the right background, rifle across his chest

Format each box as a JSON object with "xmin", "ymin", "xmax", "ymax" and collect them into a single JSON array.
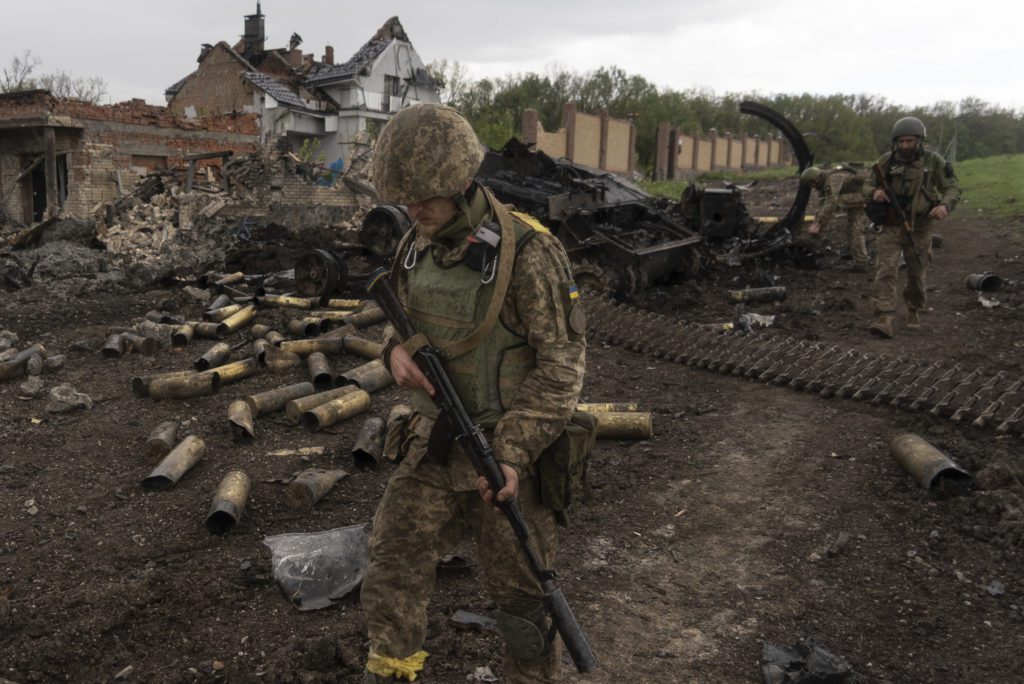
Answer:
[{"xmin": 864, "ymin": 117, "xmax": 961, "ymax": 338}]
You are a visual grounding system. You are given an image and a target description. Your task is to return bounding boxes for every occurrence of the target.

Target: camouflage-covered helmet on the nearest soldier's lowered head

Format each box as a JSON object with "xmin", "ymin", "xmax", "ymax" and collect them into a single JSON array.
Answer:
[{"xmin": 371, "ymin": 104, "xmax": 483, "ymax": 205}]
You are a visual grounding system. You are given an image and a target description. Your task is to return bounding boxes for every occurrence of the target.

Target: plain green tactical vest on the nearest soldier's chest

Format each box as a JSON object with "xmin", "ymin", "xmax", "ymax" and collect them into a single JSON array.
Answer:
[{"xmin": 398, "ymin": 221, "xmax": 537, "ymax": 428}]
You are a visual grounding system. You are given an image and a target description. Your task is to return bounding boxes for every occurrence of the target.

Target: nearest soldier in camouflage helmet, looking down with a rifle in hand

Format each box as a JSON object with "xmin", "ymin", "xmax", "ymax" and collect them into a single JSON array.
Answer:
[{"xmin": 361, "ymin": 104, "xmax": 586, "ymax": 682}]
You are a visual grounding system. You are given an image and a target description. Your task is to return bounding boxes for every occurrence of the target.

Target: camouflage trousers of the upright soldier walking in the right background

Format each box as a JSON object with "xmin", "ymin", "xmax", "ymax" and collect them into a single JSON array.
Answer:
[{"xmin": 871, "ymin": 221, "xmax": 932, "ymax": 316}]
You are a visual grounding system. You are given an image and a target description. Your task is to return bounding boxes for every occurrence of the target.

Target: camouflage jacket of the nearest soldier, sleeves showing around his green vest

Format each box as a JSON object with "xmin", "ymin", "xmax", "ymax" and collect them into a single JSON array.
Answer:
[{"xmin": 383, "ymin": 184, "xmax": 587, "ymax": 489}]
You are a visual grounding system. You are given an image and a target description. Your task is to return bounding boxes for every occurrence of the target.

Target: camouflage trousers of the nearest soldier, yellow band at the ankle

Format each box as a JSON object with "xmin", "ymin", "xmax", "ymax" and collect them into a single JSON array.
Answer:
[{"xmin": 360, "ymin": 450, "xmax": 561, "ymax": 682}]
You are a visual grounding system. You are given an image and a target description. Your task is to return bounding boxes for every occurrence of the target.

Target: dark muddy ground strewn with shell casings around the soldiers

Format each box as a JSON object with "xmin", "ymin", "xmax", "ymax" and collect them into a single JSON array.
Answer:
[{"xmin": 0, "ymin": 179, "xmax": 1024, "ymax": 684}]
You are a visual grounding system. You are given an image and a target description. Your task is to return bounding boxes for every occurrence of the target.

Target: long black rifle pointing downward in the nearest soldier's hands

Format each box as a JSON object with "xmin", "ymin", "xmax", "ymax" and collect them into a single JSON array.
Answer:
[{"xmin": 367, "ymin": 268, "xmax": 597, "ymax": 673}]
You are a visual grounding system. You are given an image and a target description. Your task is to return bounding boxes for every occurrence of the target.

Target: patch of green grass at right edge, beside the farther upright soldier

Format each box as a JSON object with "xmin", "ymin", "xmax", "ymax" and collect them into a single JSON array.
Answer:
[{"xmin": 953, "ymin": 155, "xmax": 1024, "ymax": 216}]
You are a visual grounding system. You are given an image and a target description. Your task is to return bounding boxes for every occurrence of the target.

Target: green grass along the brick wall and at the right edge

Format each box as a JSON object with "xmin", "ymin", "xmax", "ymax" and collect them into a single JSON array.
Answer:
[{"xmin": 640, "ymin": 155, "xmax": 1024, "ymax": 216}]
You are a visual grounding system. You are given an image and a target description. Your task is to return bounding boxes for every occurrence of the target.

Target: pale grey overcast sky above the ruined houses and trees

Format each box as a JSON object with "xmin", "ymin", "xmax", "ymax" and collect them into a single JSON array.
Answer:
[{"xmin": 0, "ymin": 0, "xmax": 1024, "ymax": 111}]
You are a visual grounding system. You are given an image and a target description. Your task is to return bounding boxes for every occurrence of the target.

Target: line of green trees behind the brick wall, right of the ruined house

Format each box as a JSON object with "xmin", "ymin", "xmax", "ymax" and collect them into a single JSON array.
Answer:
[{"xmin": 428, "ymin": 59, "xmax": 1024, "ymax": 172}]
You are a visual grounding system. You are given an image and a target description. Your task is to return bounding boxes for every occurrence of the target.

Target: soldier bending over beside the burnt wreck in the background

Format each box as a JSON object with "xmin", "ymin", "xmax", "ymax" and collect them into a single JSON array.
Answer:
[{"xmin": 800, "ymin": 166, "xmax": 868, "ymax": 273}]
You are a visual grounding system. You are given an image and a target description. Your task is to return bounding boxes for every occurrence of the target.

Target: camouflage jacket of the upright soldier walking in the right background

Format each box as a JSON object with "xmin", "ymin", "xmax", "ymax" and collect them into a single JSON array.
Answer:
[{"xmin": 864, "ymin": 149, "xmax": 961, "ymax": 225}]
